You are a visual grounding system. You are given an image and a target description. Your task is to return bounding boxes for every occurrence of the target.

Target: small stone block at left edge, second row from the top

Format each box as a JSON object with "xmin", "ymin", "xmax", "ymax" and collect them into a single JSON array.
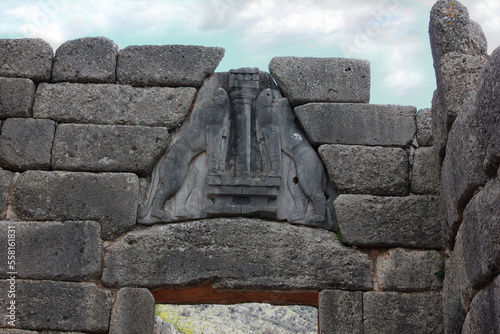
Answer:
[{"xmin": 0, "ymin": 78, "xmax": 36, "ymax": 119}]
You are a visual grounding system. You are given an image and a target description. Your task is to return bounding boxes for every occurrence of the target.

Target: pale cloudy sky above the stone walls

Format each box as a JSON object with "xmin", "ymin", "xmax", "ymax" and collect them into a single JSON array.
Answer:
[{"xmin": 0, "ymin": 0, "xmax": 500, "ymax": 108}]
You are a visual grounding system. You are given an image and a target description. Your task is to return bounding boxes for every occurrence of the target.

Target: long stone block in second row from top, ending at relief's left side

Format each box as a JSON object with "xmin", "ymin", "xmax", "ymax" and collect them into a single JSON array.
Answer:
[{"xmin": 33, "ymin": 83, "xmax": 196, "ymax": 129}]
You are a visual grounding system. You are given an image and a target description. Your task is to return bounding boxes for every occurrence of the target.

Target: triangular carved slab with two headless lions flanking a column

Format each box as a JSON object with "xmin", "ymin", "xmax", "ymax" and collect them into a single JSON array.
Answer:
[{"xmin": 138, "ymin": 68, "xmax": 337, "ymax": 230}]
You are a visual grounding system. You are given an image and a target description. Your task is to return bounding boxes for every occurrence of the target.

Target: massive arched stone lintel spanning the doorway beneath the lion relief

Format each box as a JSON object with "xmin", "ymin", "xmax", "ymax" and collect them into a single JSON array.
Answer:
[{"xmin": 103, "ymin": 218, "xmax": 372, "ymax": 291}]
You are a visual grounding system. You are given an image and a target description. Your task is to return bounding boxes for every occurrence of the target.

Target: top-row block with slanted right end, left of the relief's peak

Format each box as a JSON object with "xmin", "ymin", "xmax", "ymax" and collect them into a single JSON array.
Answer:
[{"xmin": 116, "ymin": 45, "xmax": 224, "ymax": 87}]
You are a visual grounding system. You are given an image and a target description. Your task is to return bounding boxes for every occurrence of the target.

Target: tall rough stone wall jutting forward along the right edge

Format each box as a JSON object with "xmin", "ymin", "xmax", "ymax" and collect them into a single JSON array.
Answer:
[{"xmin": 429, "ymin": 1, "xmax": 500, "ymax": 333}]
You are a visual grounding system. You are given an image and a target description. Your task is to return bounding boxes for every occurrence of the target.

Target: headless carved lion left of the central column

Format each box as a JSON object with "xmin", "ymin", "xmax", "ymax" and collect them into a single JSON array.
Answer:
[{"xmin": 138, "ymin": 88, "xmax": 230, "ymax": 225}]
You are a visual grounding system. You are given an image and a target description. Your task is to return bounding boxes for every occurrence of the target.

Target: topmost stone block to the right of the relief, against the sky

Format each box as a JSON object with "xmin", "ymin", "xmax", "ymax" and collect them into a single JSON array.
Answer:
[{"xmin": 269, "ymin": 57, "xmax": 370, "ymax": 106}]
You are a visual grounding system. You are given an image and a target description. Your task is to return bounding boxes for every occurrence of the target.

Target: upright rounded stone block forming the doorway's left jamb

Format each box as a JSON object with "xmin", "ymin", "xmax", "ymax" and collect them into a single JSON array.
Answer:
[{"xmin": 109, "ymin": 288, "xmax": 155, "ymax": 334}]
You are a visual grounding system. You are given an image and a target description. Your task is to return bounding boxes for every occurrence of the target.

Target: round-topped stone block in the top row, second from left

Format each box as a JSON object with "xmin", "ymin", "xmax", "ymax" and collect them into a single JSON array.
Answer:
[{"xmin": 52, "ymin": 37, "xmax": 118, "ymax": 83}]
